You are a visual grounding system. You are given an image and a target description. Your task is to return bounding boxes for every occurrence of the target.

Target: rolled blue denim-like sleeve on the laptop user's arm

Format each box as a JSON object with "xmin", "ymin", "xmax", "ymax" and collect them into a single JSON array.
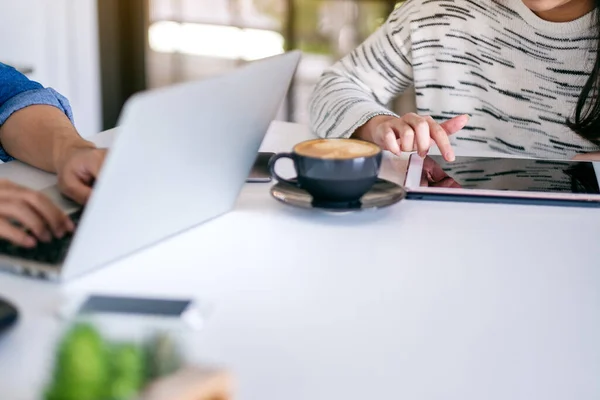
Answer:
[{"xmin": 0, "ymin": 63, "xmax": 73, "ymax": 162}]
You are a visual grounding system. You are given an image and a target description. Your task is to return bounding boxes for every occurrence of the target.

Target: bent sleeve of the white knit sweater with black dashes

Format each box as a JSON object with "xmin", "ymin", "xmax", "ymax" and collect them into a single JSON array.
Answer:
[{"xmin": 309, "ymin": 0, "xmax": 418, "ymax": 138}]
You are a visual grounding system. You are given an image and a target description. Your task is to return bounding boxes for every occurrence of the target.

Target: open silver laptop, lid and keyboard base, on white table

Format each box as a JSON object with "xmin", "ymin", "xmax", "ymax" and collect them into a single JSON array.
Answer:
[{"xmin": 0, "ymin": 51, "xmax": 301, "ymax": 281}]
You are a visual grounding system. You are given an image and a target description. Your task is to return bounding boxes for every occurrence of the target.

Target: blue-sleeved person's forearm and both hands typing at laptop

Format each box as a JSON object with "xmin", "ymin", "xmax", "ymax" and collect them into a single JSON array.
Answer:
[{"xmin": 0, "ymin": 63, "xmax": 106, "ymax": 247}]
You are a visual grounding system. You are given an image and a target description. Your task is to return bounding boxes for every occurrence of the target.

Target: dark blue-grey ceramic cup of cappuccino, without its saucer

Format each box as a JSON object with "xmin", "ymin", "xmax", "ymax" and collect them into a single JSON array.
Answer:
[{"xmin": 269, "ymin": 139, "xmax": 382, "ymax": 206}]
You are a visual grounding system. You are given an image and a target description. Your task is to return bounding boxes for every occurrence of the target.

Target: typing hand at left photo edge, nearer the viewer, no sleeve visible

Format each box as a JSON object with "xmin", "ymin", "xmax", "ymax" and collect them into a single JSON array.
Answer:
[{"xmin": 0, "ymin": 179, "xmax": 74, "ymax": 248}]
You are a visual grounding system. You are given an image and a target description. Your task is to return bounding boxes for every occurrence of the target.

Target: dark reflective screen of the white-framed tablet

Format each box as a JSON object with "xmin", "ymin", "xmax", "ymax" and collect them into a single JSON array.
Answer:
[{"xmin": 421, "ymin": 156, "xmax": 600, "ymax": 194}]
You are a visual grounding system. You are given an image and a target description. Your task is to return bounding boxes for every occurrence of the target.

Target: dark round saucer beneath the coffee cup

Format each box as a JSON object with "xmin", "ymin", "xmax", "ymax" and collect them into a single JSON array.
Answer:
[{"xmin": 271, "ymin": 179, "xmax": 406, "ymax": 212}]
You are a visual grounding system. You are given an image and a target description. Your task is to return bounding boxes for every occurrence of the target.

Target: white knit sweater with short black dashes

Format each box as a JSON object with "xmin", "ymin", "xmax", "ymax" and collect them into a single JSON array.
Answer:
[{"xmin": 309, "ymin": 0, "xmax": 600, "ymax": 158}]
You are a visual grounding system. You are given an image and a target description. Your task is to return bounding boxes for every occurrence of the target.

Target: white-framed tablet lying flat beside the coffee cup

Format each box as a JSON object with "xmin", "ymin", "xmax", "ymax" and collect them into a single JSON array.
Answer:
[{"xmin": 404, "ymin": 154, "xmax": 600, "ymax": 207}]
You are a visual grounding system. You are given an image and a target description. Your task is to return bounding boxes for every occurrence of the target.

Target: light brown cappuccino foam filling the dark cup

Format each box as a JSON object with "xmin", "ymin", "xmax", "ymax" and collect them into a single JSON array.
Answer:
[{"xmin": 294, "ymin": 139, "xmax": 381, "ymax": 160}]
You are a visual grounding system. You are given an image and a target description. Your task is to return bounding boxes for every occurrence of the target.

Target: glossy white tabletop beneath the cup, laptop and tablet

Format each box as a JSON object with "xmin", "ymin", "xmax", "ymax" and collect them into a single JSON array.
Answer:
[{"xmin": 0, "ymin": 123, "xmax": 600, "ymax": 400}]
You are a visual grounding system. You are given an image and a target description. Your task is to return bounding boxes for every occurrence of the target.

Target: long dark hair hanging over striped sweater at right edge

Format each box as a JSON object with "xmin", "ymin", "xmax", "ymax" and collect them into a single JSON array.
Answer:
[{"xmin": 567, "ymin": 0, "xmax": 600, "ymax": 145}]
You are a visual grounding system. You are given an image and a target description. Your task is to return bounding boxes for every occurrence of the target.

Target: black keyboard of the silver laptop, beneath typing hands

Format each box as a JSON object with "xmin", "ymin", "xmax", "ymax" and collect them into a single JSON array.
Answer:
[{"xmin": 0, "ymin": 209, "xmax": 83, "ymax": 264}]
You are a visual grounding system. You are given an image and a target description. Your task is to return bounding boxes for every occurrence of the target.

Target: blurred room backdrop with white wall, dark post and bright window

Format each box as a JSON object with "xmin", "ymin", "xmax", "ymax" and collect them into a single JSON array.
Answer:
[{"xmin": 0, "ymin": 0, "xmax": 410, "ymax": 136}]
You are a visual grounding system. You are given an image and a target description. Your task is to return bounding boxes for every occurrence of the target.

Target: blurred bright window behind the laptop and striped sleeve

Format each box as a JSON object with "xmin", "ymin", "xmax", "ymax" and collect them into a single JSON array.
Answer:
[{"xmin": 147, "ymin": 0, "xmax": 396, "ymax": 122}]
